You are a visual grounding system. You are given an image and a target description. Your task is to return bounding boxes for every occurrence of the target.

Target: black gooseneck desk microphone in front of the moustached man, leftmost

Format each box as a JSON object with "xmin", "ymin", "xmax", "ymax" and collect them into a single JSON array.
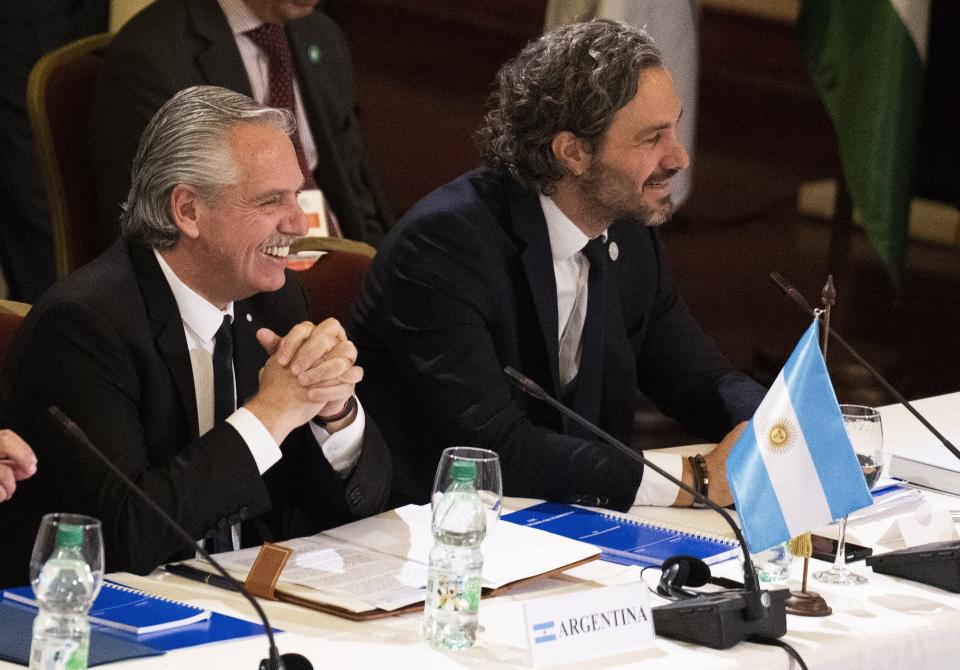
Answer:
[{"xmin": 47, "ymin": 405, "xmax": 313, "ymax": 670}]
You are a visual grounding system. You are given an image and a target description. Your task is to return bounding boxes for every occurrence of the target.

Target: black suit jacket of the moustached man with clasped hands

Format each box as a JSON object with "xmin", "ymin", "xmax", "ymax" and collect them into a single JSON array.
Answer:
[{"xmin": 0, "ymin": 240, "xmax": 390, "ymax": 584}]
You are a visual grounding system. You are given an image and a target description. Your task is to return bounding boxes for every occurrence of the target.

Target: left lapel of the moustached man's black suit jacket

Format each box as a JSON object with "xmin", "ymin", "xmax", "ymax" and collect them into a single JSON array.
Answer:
[{"xmin": 129, "ymin": 242, "xmax": 200, "ymax": 435}]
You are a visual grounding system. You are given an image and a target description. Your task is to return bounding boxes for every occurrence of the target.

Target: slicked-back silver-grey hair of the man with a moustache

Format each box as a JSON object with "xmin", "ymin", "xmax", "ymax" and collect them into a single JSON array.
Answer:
[{"xmin": 120, "ymin": 86, "xmax": 296, "ymax": 249}]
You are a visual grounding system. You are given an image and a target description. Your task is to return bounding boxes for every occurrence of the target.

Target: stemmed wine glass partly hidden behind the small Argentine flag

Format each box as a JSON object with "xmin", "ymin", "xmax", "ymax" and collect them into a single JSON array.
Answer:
[{"xmin": 813, "ymin": 405, "xmax": 883, "ymax": 585}]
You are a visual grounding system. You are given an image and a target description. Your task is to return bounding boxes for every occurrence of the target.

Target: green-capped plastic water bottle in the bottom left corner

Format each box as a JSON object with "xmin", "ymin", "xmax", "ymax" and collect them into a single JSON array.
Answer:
[{"xmin": 30, "ymin": 524, "xmax": 95, "ymax": 670}]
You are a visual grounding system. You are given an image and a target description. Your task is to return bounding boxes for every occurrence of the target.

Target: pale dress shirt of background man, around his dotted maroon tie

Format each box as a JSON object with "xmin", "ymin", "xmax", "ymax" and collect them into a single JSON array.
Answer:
[{"xmin": 218, "ymin": 0, "xmax": 317, "ymax": 172}]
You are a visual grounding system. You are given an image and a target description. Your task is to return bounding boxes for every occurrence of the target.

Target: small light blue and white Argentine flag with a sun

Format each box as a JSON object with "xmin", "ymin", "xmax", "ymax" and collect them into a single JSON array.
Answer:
[{"xmin": 727, "ymin": 319, "xmax": 873, "ymax": 553}]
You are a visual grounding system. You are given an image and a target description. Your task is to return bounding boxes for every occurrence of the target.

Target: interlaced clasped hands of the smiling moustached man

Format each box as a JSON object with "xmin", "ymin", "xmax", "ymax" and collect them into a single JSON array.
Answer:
[{"xmin": 246, "ymin": 319, "xmax": 363, "ymax": 443}]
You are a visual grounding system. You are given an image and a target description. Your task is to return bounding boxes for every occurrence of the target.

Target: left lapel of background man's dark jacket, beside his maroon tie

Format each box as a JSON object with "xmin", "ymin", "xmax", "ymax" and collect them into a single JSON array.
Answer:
[{"xmin": 187, "ymin": 0, "xmax": 253, "ymax": 97}]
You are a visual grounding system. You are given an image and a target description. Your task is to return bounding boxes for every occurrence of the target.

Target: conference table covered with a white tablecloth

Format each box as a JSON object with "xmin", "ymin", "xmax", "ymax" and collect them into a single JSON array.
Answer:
[{"xmin": 0, "ymin": 393, "xmax": 960, "ymax": 670}]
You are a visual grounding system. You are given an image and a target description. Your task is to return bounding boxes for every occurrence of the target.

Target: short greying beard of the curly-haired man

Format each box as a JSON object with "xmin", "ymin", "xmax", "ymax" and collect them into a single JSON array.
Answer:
[{"xmin": 580, "ymin": 158, "xmax": 677, "ymax": 227}]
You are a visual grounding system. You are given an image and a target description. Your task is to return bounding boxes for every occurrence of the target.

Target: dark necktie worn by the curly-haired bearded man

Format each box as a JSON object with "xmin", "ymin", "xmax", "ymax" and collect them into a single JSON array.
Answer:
[{"xmin": 568, "ymin": 236, "xmax": 608, "ymax": 439}]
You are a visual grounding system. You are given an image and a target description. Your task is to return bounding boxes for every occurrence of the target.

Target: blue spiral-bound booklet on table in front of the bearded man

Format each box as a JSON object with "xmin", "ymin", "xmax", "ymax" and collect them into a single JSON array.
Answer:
[{"xmin": 503, "ymin": 502, "xmax": 740, "ymax": 567}]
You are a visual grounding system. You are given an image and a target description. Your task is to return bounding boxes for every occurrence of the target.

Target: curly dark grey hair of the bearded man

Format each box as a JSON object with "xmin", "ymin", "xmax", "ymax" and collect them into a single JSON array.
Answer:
[{"xmin": 476, "ymin": 19, "xmax": 663, "ymax": 194}]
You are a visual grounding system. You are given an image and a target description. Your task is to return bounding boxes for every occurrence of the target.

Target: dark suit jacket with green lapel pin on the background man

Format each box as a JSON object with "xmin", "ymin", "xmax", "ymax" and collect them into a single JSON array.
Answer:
[{"xmin": 90, "ymin": 0, "xmax": 392, "ymax": 248}]
